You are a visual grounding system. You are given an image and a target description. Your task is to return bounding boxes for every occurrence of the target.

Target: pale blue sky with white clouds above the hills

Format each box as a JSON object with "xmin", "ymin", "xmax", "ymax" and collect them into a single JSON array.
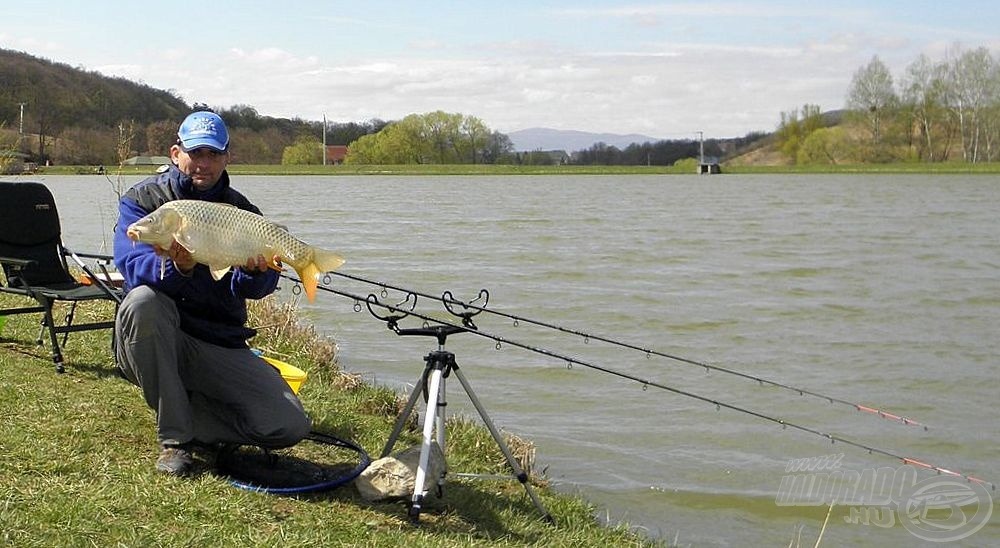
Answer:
[{"xmin": 0, "ymin": 0, "xmax": 1000, "ymax": 138}]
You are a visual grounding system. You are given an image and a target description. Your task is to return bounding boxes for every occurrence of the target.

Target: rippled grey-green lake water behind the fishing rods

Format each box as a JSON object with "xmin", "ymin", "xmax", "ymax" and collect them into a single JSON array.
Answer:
[{"xmin": 33, "ymin": 175, "xmax": 1000, "ymax": 546}]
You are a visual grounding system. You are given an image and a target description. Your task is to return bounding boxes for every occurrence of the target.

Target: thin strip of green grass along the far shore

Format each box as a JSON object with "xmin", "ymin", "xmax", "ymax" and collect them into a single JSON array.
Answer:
[{"xmin": 31, "ymin": 162, "xmax": 1000, "ymax": 176}]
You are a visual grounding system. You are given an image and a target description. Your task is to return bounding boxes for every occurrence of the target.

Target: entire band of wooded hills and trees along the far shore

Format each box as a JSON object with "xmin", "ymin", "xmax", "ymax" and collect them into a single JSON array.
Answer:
[{"xmin": 17, "ymin": 45, "xmax": 1000, "ymax": 169}]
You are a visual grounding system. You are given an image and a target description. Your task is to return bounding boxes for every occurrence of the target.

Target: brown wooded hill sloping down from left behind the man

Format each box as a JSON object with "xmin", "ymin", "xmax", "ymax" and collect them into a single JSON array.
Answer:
[{"xmin": 0, "ymin": 48, "xmax": 318, "ymax": 165}]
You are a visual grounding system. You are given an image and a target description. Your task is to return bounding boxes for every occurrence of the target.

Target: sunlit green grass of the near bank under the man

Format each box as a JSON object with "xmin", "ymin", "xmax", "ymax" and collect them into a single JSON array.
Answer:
[{"xmin": 0, "ymin": 295, "xmax": 650, "ymax": 547}]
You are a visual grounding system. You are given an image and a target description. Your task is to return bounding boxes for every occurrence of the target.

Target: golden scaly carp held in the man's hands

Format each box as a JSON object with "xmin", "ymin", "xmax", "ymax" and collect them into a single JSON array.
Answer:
[{"xmin": 126, "ymin": 200, "xmax": 344, "ymax": 302}]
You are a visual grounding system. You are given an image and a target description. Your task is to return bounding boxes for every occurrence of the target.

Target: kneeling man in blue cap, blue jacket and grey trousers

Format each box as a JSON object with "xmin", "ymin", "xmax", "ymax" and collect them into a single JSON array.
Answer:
[{"xmin": 114, "ymin": 111, "xmax": 311, "ymax": 475}]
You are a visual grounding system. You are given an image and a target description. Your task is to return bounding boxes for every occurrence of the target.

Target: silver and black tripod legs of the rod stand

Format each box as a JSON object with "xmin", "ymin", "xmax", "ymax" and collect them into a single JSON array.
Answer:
[{"xmin": 382, "ymin": 351, "xmax": 552, "ymax": 523}]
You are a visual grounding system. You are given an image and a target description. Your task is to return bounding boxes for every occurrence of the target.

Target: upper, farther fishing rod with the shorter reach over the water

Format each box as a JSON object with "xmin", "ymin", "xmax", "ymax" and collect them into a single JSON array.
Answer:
[{"xmin": 324, "ymin": 272, "xmax": 929, "ymax": 430}]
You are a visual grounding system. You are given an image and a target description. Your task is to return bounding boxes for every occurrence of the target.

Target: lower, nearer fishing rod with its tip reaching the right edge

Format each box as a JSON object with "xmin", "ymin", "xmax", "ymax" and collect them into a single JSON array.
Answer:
[{"xmin": 281, "ymin": 273, "xmax": 996, "ymax": 491}]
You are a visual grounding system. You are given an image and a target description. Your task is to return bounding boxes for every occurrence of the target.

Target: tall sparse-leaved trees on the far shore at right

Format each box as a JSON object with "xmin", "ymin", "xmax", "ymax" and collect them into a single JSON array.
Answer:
[{"xmin": 775, "ymin": 45, "xmax": 1000, "ymax": 164}]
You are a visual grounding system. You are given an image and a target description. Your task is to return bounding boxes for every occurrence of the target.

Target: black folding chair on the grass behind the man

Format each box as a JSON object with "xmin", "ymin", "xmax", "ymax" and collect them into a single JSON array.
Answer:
[{"xmin": 0, "ymin": 182, "xmax": 122, "ymax": 373}]
